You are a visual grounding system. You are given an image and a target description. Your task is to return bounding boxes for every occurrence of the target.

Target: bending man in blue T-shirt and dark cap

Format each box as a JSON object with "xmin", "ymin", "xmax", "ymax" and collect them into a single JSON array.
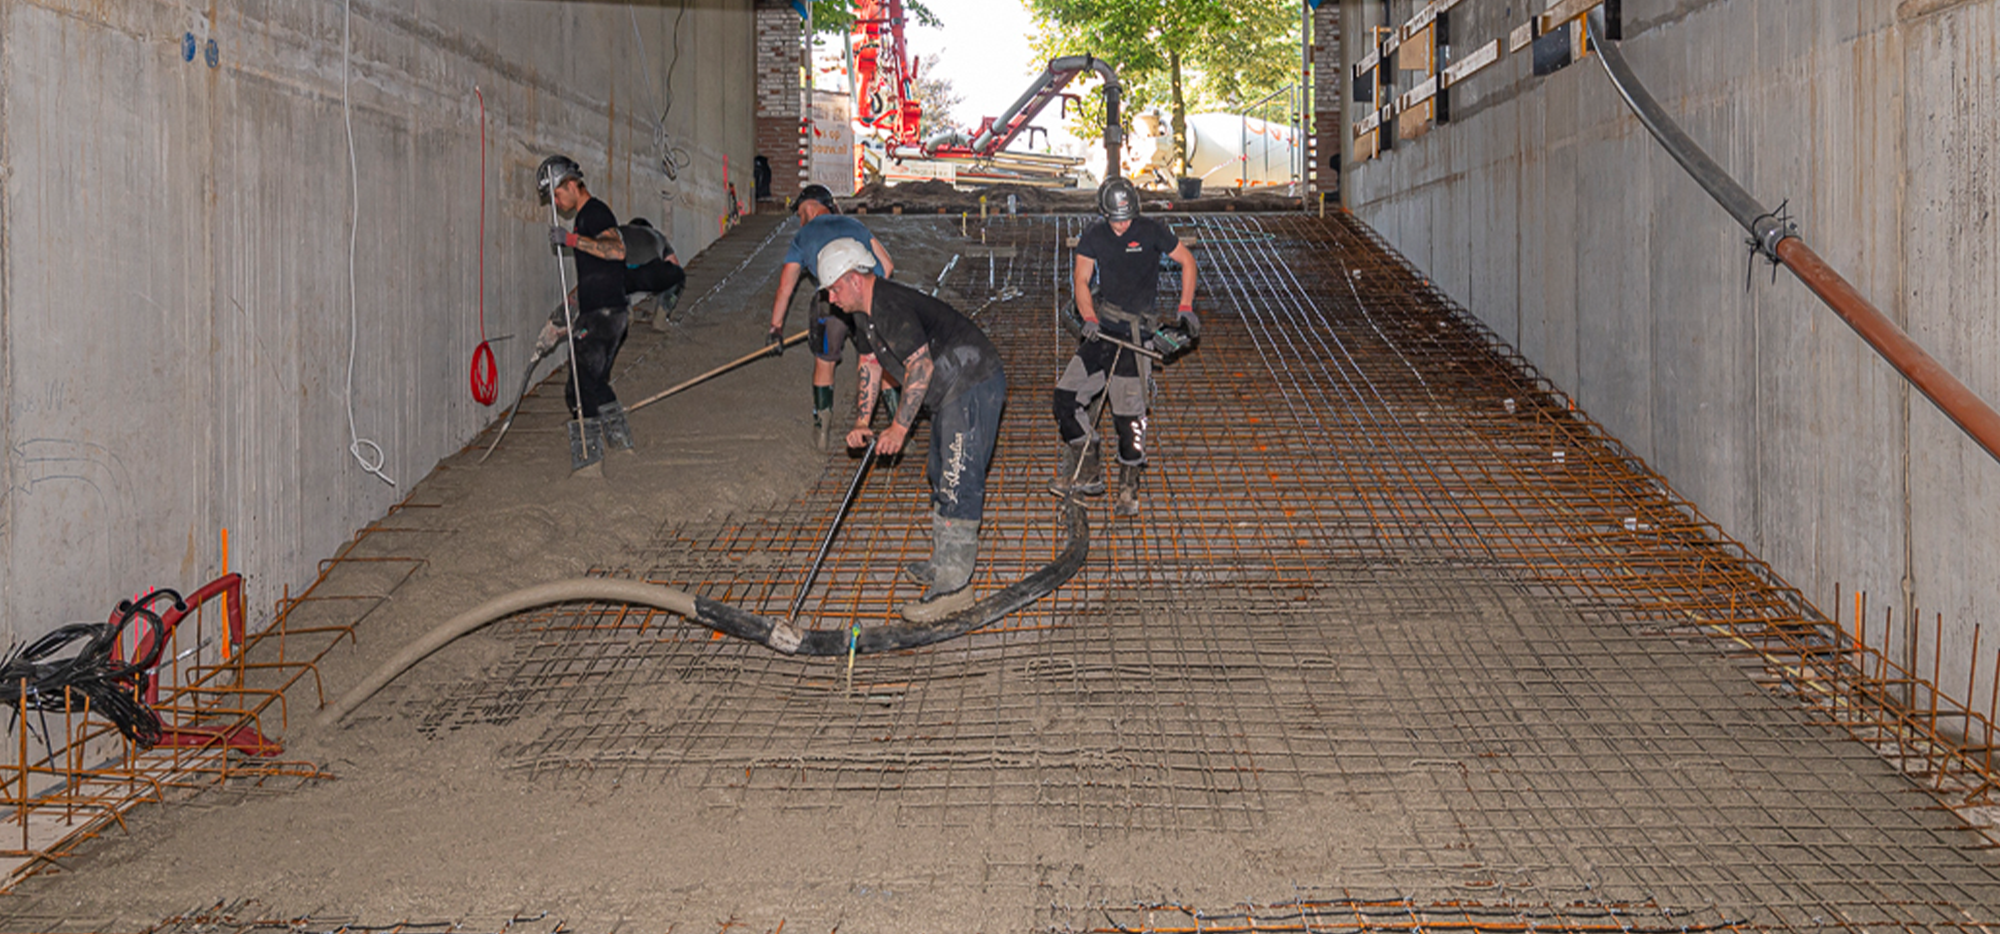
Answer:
[{"xmin": 764, "ymin": 184, "xmax": 896, "ymax": 450}]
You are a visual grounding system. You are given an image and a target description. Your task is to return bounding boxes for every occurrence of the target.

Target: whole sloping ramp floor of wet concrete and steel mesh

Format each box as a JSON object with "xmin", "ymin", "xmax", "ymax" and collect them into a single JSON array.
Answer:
[{"xmin": 0, "ymin": 212, "xmax": 2000, "ymax": 932}]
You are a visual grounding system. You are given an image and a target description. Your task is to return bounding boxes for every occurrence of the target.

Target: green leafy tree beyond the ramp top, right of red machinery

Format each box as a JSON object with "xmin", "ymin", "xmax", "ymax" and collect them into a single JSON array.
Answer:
[{"xmin": 1026, "ymin": 0, "xmax": 1298, "ymax": 172}]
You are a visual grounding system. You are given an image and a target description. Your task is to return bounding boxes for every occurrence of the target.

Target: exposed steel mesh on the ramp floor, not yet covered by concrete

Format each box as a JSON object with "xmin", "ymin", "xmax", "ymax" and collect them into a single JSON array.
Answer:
[{"xmin": 406, "ymin": 214, "xmax": 2000, "ymax": 932}]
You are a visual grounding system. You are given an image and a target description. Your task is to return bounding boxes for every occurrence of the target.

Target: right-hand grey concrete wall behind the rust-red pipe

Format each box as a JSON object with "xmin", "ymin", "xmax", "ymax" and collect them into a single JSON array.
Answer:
[{"xmin": 1344, "ymin": 0, "xmax": 2000, "ymax": 710}]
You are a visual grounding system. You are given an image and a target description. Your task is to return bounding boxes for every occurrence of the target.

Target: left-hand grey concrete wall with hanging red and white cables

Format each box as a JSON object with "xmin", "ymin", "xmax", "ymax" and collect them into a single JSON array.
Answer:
[{"xmin": 0, "ymin": 0, "xmax": 754, "ymax": 652}]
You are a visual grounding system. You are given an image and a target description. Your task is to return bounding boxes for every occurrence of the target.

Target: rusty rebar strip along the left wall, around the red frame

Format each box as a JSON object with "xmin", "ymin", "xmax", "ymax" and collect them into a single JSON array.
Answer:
[{"xmin": 0, "ymin": 502, "xmax": 432, "ymax": 892}]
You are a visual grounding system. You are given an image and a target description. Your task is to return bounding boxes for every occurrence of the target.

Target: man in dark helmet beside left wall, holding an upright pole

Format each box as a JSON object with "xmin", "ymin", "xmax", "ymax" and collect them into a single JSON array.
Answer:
[{"xmin": 536, "ymin": 156, "xmax": 632, "ymax": 476}]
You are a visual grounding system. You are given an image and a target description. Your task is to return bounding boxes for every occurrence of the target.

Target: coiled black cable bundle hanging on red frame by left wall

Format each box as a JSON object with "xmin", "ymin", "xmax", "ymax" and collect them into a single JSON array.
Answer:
[{"xmin": 0, "ymin": 588, "xmax": 188, "ymax": 750}]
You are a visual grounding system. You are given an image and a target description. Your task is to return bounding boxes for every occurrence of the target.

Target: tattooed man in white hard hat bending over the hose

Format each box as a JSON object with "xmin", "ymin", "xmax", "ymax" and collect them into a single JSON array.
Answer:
[{"xmin": 816, "ymin": 238, "xmax": 1006, "ymax": 622}]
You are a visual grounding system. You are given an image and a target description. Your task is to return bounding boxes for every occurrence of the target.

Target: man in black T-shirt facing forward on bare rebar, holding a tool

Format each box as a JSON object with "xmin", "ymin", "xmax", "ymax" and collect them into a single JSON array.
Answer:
[{"xmin": 1050, "ymin": 176, "xmax": 1202, "ymax": 516}]
